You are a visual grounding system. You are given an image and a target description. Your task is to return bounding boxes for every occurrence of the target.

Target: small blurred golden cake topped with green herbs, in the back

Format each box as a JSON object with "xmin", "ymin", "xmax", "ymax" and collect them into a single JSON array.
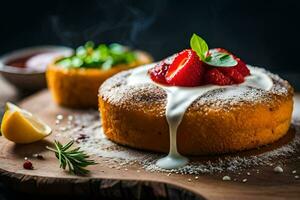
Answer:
[{"xmin": 46, "ymin": 43, "xmax": 152, "ymax": 108}]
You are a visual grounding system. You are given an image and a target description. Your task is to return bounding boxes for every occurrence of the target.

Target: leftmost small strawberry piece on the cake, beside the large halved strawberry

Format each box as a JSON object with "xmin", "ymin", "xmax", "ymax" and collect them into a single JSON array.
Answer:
[{"xmin": 148, "ymin": 60, "xmax": 169, "ymax": 84}]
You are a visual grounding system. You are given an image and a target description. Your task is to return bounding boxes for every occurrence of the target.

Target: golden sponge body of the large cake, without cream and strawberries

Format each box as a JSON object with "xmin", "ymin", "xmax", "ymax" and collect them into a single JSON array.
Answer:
[{"xmin": 99, "ymin": 65, "xmax": 293, "ymax": 155}]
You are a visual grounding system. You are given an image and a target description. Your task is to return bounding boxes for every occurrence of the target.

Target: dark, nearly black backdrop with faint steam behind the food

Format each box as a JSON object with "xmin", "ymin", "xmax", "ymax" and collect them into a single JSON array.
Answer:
[{"xmin": 0, "ymin": 0, "xmax": 300, "ymax": 85}]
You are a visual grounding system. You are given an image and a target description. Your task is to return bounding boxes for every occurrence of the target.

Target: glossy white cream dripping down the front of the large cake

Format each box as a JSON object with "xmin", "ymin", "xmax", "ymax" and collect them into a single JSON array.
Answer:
[{"xmin": 127, "ymin": 63, "xmax": 273, "ymax": 169}]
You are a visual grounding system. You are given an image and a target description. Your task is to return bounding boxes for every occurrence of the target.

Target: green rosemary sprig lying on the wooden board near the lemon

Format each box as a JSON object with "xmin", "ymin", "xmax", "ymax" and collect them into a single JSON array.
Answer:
[{"xmin": 46, "ymin": 140, "xmax": 97, "ymax": 175}]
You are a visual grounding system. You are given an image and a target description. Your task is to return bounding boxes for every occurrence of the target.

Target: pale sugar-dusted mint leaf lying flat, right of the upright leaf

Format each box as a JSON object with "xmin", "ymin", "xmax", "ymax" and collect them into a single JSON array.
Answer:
[{"xmin": 204, "ymin": 50, "xmax": 238, "ymax": 67}]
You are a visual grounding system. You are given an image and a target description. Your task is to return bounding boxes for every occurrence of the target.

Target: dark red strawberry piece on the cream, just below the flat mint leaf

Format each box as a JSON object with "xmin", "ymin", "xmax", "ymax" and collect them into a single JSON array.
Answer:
[{"xmin": 204, "ymin": 68, "xmax": 234, "ymax": 85}]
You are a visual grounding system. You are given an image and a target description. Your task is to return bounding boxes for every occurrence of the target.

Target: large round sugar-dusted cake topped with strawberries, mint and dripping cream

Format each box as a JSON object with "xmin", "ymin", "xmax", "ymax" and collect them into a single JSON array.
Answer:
[{"xmin": 99, "ymin": 35, "xmax": 293, "ymax": 168}]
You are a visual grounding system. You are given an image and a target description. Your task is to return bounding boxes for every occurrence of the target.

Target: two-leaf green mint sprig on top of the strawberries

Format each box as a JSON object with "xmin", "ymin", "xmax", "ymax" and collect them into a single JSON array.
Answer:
[{"xmin": 190, "ymin": 33, "xmax": 237, "ymax": 67}]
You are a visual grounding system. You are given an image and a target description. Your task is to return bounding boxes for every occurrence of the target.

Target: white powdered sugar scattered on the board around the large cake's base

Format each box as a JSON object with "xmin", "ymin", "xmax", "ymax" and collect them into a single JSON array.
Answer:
[{"xmin": 55, "ymin": 111, "xmax": 300, "ymax": 174}]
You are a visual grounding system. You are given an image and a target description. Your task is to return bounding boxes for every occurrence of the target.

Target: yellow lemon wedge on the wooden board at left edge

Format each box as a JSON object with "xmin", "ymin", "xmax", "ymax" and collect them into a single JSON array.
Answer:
[{"xmin": 1, "ymin": 103, "xmax": 52, "ymax": 144}]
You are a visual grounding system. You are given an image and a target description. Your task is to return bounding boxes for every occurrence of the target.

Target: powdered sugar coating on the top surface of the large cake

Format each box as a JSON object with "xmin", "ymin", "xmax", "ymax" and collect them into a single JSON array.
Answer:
[{"xmin": 99, "ymin": 64, "xmax": 293, "ymax": 115}]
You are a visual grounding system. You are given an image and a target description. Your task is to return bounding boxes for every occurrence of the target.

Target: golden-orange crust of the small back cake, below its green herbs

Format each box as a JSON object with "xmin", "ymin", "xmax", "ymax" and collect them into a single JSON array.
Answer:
[{"xmin": 46, "ymin": 51, "xmax": 152, "ymax": 108}]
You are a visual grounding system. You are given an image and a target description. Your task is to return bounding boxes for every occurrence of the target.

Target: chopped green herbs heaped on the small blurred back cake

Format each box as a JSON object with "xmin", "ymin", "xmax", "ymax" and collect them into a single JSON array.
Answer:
[{"xmin": 56, "ymin": 41, "xmax": 137, "ymax": 70}]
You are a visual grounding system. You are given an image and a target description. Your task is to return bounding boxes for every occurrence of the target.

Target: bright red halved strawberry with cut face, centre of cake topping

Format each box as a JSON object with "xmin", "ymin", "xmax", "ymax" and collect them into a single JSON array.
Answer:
[{"xmin": 166, "ymin": 49, "xmax": 204, "ymax": 87}]
